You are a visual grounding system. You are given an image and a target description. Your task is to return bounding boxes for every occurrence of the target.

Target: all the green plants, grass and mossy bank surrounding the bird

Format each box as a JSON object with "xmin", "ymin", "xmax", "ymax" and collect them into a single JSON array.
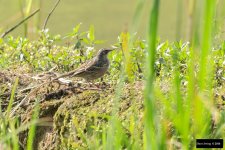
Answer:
[{"xmin": 0, "ymin": 0, "xmax": 225, "ymax": 149}]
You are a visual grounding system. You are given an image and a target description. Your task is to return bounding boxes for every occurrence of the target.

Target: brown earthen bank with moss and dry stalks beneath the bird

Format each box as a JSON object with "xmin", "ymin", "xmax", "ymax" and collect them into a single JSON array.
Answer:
[{"xmin": 1, "ymin": 71, "xmax": 143, "ymax": 149}]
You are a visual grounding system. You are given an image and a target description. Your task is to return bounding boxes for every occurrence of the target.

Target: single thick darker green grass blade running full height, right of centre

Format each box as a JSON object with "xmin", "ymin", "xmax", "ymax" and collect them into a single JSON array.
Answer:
[{"xmin": 144, "ymin": 0, "xmax": 165, "ymax": 149}]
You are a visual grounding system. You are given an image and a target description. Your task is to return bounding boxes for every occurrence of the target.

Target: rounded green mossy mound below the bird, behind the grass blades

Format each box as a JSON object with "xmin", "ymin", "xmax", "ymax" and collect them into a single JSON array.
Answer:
[{"xmin": 54, "ymin": 82, "xmax": 143, "ymax": 149}]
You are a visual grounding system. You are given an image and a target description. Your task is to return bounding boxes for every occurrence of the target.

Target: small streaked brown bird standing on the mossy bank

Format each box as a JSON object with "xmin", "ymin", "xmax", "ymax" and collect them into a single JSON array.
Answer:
[{"xmin": 53, "ymin": 48, "xmax": 114, "ymax": 82}]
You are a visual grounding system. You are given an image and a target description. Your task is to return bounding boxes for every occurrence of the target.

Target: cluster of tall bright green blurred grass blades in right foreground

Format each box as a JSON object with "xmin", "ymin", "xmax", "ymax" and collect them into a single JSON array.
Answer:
[{"xmin": 144, "ymin": 0, "xmax": 223, "ymax": 149}]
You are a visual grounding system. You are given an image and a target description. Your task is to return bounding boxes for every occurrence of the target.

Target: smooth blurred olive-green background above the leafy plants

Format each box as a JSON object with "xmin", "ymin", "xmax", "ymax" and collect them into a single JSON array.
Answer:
[{"xmin": 0, "ymin": 0, "xmax": 224, "ymax": 45}]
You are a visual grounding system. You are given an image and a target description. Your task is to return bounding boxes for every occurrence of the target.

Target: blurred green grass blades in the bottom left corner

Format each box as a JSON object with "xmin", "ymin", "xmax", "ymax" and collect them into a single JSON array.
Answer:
[{"xmin": 0, "ymin": 78, "xmax": 39, "ymax": 150}]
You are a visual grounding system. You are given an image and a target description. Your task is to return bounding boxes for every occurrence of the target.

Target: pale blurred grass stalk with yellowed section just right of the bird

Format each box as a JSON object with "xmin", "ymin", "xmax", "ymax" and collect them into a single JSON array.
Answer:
[{"xmin": 102, "ymin": 0, "xmax": 146, "ymax": 150}]
